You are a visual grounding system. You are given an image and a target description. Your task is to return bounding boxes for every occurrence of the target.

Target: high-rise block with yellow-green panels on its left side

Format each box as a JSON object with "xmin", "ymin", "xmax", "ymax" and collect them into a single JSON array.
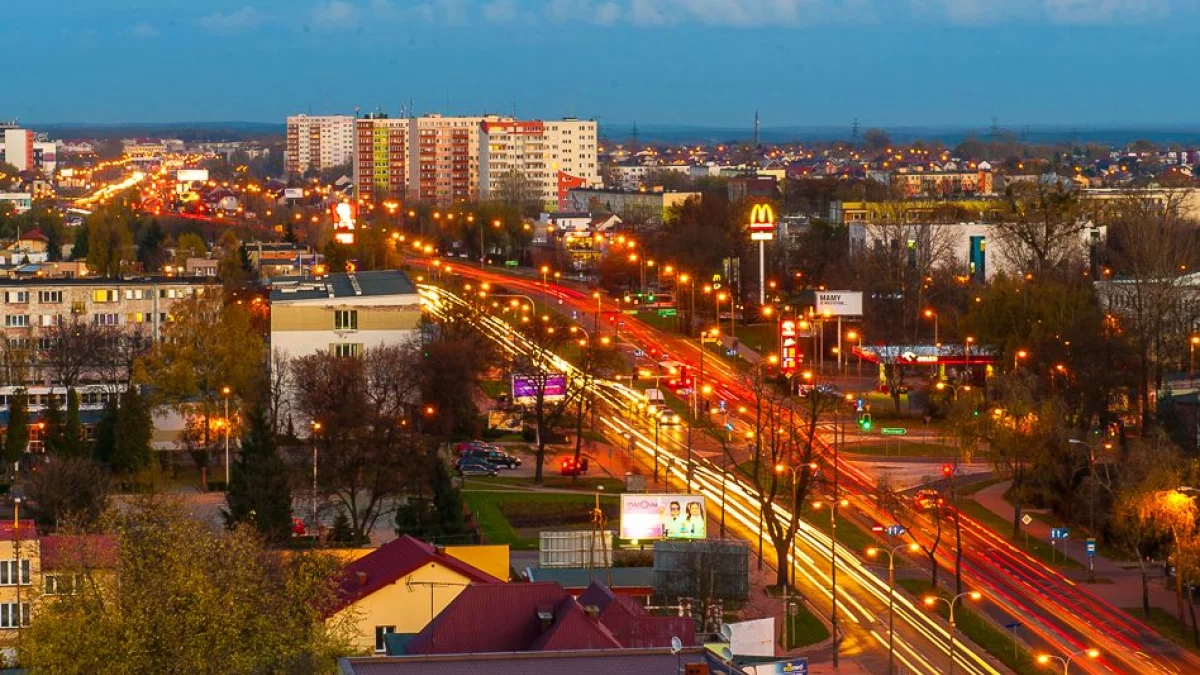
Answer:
[{"xmin": 354, "ymin": 113, "xmax": 409, "ymax": 202}]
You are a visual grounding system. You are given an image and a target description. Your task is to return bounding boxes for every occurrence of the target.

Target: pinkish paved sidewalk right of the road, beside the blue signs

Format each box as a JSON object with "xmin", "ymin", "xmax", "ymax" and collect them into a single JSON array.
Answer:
[{"xmin": 973, "ymin": 480, "xmax": 1177, "ymax": 619}]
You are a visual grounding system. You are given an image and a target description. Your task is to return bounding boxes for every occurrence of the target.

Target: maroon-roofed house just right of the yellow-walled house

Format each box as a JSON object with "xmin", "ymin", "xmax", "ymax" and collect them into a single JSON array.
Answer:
[{"xmin": 404, "ymin": 583, "xmax": 696, "ymax": 655}]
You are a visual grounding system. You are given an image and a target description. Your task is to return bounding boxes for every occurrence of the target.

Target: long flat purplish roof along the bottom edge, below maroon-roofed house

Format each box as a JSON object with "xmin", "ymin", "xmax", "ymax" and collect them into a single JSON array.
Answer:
[{"xmin": 337, "ymin": 647, "xmax": 746, "ymax": 675}]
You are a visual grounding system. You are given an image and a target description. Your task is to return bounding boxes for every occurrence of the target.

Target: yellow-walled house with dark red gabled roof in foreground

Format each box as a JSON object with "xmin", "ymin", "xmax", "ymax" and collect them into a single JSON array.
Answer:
[{"xmin": 329, "ymin": 536, "xmax": 508, "ymax": 652}]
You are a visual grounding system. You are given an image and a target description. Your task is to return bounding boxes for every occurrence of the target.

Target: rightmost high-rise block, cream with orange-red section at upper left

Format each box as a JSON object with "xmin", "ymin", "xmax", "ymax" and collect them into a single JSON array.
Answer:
[{"xmin": 479, "ymin": 119, "xmax": 600, "ymax": 209}]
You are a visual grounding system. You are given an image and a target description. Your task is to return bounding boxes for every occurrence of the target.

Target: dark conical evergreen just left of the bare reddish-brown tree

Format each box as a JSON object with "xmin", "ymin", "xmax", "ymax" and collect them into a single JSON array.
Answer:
[{"xmin": 224, "ymin": 405, "xmax": 292, "ymax": 543}]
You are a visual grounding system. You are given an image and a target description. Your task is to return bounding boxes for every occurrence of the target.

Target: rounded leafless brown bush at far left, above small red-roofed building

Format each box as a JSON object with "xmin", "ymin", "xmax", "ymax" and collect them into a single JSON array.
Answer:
[{"xmin": 29, "ymin": 456, "xmax": 108, "ymax": 530}]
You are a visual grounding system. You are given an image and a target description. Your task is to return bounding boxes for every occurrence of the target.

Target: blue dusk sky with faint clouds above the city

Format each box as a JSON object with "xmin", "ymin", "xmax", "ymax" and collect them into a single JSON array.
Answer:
[{"xmin": 9, "ymin": 0, "xmax": 1200, "ymax": 129}]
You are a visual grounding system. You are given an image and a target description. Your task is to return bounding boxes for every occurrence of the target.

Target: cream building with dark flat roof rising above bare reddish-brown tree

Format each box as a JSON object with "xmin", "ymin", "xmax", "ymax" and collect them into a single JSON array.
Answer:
[{"xmin": 270, "ymin": 270, "xmax": 421, "ymax": 358}]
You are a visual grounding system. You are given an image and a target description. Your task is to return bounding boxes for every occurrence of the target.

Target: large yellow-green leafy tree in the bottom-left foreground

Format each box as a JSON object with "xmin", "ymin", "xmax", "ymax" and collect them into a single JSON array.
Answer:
[{"xmin": 20, "ymin": 497, "xmax": 352, "ymax": 675}]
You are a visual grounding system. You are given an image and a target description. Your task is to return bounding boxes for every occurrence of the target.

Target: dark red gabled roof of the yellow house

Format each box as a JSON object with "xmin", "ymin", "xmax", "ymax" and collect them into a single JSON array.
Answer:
[{"xmin": 332, "ymin": 534, "xmax": 502, "ymax": 613}]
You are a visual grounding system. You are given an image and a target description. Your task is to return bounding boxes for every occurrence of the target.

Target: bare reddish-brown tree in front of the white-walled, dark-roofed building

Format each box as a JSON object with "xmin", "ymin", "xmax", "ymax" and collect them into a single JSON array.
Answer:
[{"xmin": 292, "ymin": 342, "xmax": 427, "ymax": 540}]
